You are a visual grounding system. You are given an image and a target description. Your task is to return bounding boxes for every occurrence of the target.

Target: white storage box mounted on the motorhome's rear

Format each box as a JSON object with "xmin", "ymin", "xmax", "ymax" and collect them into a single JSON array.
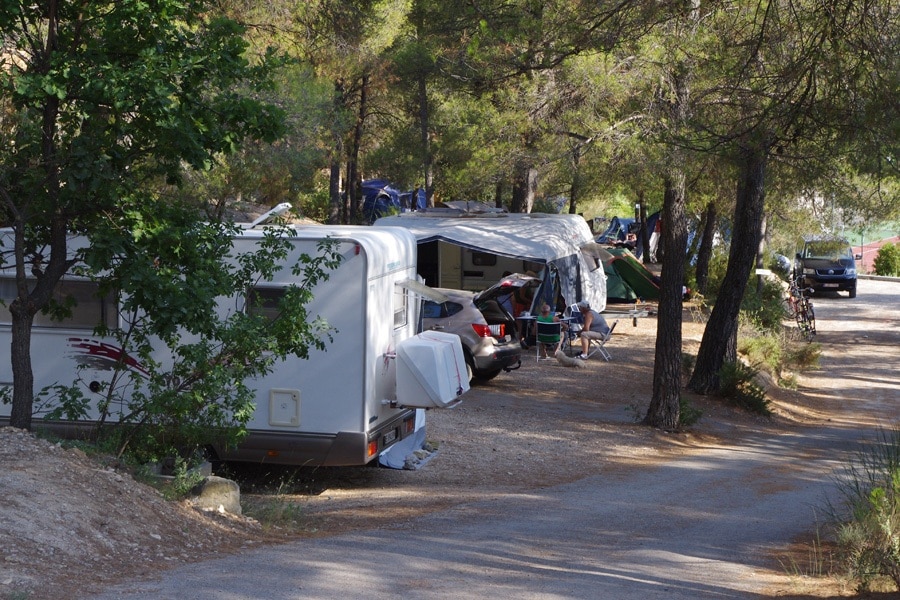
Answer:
[{"xmin": 397, "ymin": 331, "xmax": 469, "ymax": 408}]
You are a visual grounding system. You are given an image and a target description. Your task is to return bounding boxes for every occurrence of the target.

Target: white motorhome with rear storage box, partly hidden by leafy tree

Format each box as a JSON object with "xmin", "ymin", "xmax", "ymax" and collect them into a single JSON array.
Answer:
[{"xmin": 0, "ymin": 225, "xmax": 469, "ymax": 466}]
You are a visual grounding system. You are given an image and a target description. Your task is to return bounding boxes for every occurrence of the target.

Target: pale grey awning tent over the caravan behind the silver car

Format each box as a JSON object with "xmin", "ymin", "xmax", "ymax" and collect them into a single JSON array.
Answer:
[{"xmin": 375, "ymin": 209, "xmax": 606, "ymax": 311}]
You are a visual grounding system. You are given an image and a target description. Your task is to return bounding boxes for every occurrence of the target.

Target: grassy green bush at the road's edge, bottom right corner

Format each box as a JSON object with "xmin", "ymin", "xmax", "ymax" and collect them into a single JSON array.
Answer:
[{"xmin": 831, "ymin": 428, "xmax": 900, "ymax": 591}]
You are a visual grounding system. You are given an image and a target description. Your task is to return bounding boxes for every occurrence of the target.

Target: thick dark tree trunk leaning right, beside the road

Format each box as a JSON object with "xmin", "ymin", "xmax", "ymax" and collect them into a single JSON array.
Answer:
[{"xmin": 688, "ymin": 145, "xmax": 768, "ymax": 394}]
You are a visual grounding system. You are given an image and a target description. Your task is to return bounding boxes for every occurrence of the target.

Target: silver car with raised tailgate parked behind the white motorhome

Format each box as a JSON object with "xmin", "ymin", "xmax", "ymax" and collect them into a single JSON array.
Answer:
[{"xmin": 422, "ymin": 286, "xmax": 522, "ymax": 382}]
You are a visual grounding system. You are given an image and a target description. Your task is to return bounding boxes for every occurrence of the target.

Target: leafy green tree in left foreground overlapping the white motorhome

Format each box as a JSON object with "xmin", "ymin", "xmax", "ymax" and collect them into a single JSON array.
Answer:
[{"xmin": 0, "ymin": 0, "xmax": 284, "ymax": 434}]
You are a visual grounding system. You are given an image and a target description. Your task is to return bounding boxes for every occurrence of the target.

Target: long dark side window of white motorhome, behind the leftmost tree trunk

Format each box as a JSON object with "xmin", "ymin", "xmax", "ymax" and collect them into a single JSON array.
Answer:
[{"xmin": 0, "ymin": 278, "xmax": 117, "ymax": 330}]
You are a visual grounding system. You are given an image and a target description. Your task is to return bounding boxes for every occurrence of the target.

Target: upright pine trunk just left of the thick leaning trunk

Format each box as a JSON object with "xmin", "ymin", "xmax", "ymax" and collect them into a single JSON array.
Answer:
[{"xmin": 644, "ymin": 170, "xmax": 687, "ymax": 429}]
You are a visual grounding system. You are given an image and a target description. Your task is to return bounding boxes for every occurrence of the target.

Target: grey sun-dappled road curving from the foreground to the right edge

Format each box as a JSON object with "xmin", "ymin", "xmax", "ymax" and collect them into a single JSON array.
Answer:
[{"xmin": 86, "ymin": 280, "xmax": 900, "ymax": 600}]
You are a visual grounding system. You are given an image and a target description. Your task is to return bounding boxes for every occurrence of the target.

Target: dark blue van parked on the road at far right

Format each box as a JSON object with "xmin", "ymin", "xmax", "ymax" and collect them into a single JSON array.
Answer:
[{"xmin": 797, "ymin": 238, "xmax": 862, "ymax": 298}]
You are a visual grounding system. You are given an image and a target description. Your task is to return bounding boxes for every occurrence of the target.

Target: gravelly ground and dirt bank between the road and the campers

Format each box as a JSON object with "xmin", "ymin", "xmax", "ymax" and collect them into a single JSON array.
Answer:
[{"xmin": 0, "ymin": 298, "xmax": 888, "ymax": 599}]
